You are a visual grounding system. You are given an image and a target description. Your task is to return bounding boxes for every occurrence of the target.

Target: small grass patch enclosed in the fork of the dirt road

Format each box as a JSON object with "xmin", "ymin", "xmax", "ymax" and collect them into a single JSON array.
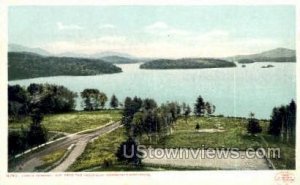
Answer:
[{"xmin": 36, "ymin": 149, "xmax": 67, "ymax": 170}]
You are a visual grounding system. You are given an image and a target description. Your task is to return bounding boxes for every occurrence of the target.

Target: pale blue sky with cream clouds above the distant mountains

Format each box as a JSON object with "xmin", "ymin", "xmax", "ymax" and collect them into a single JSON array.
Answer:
[{"xmin": 8, "ymin": 5, "xmax": 296, "ymax": 58}]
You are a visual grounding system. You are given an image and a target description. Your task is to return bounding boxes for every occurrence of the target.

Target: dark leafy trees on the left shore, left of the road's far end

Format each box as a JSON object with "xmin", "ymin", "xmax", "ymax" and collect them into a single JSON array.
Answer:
[{"xmin": 8, "ymin": 83, "xmax": 120, "ymax": 156}]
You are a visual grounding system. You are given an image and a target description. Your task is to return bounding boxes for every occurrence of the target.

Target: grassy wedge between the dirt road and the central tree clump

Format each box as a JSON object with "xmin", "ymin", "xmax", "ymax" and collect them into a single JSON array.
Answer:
[{"xmin": 68, "ymin": 128, "xmax": 126, "ymax": 171}]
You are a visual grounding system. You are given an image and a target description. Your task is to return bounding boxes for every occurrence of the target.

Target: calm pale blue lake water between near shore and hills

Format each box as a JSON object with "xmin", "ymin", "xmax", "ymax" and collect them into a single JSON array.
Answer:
[{"xmin": 9, "ymin": 63, "xmax": 296, "ymax": 118}]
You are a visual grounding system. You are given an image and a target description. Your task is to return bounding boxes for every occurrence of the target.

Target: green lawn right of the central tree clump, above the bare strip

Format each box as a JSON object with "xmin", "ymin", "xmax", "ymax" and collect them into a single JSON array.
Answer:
[{"xmin": 141, "ymin": 116, "xmax": 295, "ymax": 169}]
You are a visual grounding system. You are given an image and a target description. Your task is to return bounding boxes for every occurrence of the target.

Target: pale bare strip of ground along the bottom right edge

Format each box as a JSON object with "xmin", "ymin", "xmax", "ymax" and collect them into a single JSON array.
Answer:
[{"xmin": 143, "ymin": 149, "xmax": 270, "ymax": 170}]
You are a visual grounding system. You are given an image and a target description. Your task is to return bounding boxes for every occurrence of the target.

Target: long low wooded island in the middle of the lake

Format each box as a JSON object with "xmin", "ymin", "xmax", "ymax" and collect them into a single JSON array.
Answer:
[{"xmin": 140, "ymin": 58, "xmax": 236, "ymax": 69}]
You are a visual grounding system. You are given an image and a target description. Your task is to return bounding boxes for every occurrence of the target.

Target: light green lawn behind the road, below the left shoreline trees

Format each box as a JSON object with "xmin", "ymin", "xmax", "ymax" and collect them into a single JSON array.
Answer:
[{"xmin": 9, "ymin": 110, "xmax": 121, "ymax": 133}]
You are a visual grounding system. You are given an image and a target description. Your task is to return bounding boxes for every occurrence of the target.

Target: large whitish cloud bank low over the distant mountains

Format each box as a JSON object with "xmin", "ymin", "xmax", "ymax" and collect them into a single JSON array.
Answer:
[{"xmin": 43, "ymin": 25, "xmax": 280, "ymax": 58}]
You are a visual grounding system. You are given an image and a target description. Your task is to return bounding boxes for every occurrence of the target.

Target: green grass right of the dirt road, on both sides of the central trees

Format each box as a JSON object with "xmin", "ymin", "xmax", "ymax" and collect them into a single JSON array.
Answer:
[{"xmin": 69, "ymin": 116, "xmax": 295, "ymax": 171}]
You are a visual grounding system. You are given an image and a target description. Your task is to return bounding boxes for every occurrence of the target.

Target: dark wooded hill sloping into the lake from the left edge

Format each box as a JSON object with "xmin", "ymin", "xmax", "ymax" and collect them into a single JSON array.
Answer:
[{"xmin": 8, "ymin": 52, "xmax": 122, "ymax": 80}]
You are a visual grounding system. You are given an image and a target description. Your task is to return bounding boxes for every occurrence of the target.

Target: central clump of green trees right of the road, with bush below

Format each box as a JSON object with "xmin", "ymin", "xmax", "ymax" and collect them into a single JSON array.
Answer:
[{"xmin": 116, "ymin": 96, "xmax": 216, "ymax": 165}]
